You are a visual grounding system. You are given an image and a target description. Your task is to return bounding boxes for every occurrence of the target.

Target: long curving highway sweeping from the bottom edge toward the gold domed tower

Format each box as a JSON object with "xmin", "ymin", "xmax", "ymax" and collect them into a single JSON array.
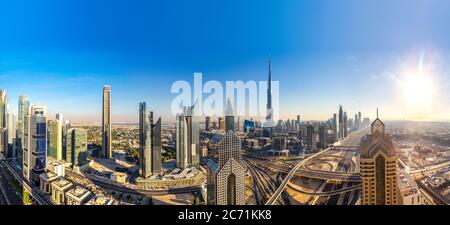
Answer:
[{"xmin": 265, "ymin": 129, "xmax": 369, "ymax": 205}]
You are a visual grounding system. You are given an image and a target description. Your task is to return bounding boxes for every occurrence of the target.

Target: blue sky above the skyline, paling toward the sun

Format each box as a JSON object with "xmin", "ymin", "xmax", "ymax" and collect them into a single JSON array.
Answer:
[{"xmin": 0, "ymin": 0, "xmax": 450, "ymax": 122}]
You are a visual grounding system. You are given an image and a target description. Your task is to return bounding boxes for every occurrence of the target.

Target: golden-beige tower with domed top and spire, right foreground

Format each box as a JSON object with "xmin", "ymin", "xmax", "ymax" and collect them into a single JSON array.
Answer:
[{"xmin": 359, "ymin": 110, "xmax": 399, "ymax": 205}]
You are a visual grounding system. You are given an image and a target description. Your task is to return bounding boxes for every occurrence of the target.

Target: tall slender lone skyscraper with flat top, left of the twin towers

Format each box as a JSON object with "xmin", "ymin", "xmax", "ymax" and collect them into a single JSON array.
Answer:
[{"xmin": 101, "ymin": 85, "xmax": 112, "ymax": 159}]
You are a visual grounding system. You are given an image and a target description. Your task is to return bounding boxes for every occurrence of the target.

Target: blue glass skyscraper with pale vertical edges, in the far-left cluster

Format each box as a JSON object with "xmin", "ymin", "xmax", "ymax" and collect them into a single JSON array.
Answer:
[{"xmin": 24, "ymin": 104, "xmax": 47, "ymax": 185}]
